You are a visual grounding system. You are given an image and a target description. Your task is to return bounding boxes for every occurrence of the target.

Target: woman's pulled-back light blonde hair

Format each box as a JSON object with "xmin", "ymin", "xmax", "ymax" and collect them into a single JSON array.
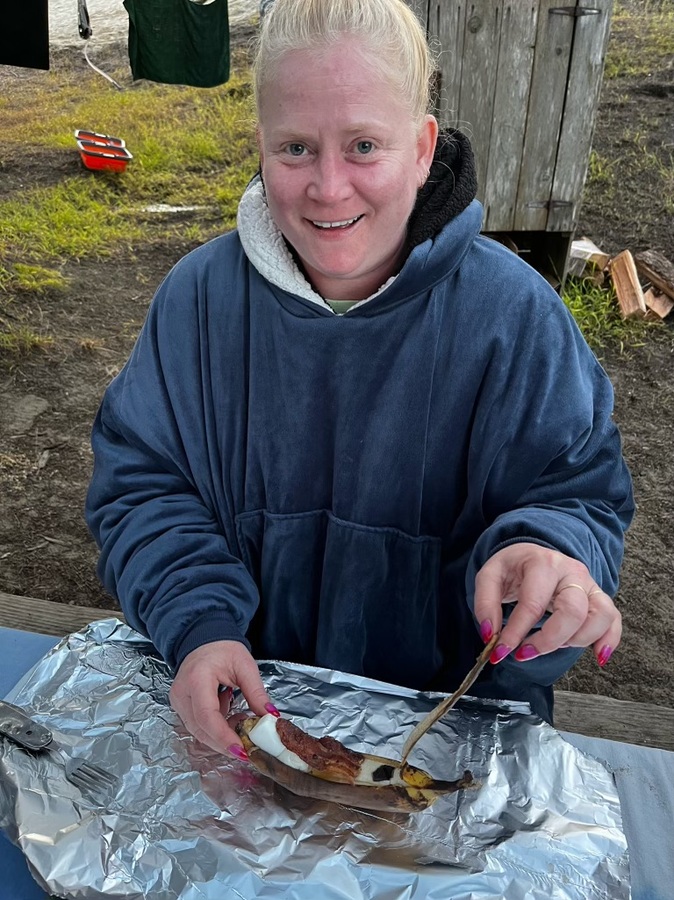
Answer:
[{"xmin": 253, "ymin": 0, "xmax": 434, "ymax": 125}]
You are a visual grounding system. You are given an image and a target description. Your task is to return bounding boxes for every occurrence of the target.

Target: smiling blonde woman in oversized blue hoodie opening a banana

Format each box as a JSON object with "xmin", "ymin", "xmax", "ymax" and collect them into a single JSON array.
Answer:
[{"xmin": 87, "ymin": 0, "xmax": 633, "ymax": 756}]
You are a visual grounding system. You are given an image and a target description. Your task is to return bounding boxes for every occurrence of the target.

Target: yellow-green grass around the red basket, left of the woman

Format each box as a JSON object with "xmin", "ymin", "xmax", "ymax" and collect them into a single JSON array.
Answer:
[{"xmin": 0, "ymin": 49, "xmax": 257, "ymax": 284}]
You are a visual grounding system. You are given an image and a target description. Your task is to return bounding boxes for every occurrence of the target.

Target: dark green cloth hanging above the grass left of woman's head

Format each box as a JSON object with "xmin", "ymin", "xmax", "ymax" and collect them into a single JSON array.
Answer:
[{"xmin": 124, "ymin": 0, "xmax": 229, "ymax": 87}]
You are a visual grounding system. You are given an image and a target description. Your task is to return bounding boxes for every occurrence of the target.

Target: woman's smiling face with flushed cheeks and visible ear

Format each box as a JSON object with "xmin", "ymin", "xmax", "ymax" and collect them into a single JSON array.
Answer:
[{"xmin": 258, "ymin": 38, "xmax": 437, "ymax": 300}]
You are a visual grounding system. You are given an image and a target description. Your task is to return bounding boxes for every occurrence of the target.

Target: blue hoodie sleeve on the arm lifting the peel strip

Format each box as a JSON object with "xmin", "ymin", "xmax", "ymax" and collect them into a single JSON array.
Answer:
[{"xmin": 466, "ymin": 270, "xmax": 634, "ymax": 685}]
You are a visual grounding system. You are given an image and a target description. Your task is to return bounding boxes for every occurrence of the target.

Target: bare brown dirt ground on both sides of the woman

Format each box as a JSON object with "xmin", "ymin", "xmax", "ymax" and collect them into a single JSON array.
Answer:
[{"xmin": 0, "ymin": 19, "xmax": 674, "ymax": 707}]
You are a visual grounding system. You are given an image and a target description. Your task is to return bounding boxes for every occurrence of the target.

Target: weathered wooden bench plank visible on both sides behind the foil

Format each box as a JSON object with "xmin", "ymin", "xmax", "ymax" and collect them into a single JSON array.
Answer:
[{"xmin": 0, "ymin": 591, "xmax": 674, "ymax": 750}]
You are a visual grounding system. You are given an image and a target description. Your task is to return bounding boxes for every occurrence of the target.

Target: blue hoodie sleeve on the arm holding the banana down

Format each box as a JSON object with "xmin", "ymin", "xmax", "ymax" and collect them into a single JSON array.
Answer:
[{"xmin": 86, "ymin": 250, "xmax": 258, "ymax": 668}]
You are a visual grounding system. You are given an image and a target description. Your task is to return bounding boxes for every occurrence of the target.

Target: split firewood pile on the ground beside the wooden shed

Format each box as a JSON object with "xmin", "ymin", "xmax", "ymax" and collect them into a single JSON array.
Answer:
[{"xmin": 571, "ymin": 238, "xmax": 674, "ymax": 319}]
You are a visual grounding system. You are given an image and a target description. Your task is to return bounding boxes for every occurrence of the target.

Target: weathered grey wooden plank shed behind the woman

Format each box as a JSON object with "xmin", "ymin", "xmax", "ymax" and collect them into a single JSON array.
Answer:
[{"xmin": 409, "ymin": 0, "xmax": 612, "ymax": 286}]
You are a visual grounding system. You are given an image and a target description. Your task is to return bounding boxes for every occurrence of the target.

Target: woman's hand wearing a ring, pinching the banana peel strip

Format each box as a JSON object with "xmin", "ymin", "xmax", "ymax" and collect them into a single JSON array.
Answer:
[{"xmin": 475, "ymin": 543, "xmax": 622, "ymax": 666}]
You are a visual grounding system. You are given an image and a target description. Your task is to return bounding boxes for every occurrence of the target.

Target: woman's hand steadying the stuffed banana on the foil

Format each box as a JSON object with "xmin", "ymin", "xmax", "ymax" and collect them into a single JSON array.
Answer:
[{"xmin": 170, "ymin": 641, "xmax": 278, "ymax": 759}]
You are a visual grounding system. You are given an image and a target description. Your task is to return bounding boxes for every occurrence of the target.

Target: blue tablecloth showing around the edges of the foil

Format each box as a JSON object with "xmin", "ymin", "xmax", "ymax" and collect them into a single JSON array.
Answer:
[{"xmin": 0, "ymin": 627, "xmax": 674, "ymax": 900}]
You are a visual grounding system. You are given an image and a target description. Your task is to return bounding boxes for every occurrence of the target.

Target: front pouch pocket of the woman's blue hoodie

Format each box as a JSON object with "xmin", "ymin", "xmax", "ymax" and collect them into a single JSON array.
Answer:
[{"xmin": 237, "ymin": 510, "xmax": 441, "ymax": 685}]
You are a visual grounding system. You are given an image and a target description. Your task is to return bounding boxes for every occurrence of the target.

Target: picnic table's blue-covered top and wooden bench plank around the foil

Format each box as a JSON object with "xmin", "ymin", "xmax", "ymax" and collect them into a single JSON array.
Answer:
[{"xmin": 0, "ymin": 592, "xmax": 674, "ymax": 900}]
